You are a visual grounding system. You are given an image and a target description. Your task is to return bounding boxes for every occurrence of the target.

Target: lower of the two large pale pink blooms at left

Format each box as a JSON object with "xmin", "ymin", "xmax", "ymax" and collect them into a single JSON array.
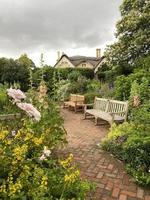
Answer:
[{"xmin": 17, "ymin": 103, "xmax": 41, "ymax": 121}]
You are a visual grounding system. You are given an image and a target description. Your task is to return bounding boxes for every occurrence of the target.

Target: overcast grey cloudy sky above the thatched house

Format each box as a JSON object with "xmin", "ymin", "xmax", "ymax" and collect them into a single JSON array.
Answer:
[{"xmin": 0, "ymin": 0, "xmax": 122, "ymax": 65}]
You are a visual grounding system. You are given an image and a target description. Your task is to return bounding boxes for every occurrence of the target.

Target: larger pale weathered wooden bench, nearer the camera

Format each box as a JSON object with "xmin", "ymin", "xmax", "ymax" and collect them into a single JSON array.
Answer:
[{"xmin": 84, "ymin": 97, "xmax": 128, "ymax": 125}]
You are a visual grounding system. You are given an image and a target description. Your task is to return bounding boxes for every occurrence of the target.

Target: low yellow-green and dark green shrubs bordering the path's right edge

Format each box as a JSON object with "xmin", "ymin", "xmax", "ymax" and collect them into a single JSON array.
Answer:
[{"xmin": 102, "ymin": 123, "xmax": 150, "ymax": 186}]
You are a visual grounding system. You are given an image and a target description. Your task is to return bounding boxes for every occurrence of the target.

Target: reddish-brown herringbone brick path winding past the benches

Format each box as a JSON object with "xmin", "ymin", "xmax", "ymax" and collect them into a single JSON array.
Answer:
[{"xmin": 59, "ymin": 109, "xmax": 150, "ymax": 200}]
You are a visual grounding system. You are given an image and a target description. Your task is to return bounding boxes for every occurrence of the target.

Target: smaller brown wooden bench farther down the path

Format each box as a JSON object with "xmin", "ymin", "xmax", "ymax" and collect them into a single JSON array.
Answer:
[{"xmin": 63, "ymin": 94, "xmax": 85, "ymax": 112}]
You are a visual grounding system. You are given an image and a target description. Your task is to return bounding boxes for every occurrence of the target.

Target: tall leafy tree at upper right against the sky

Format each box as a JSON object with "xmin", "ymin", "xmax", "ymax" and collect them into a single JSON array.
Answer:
[{"xmin": 105, "ymin": 0, "xmax": 150, "ymax": 70}]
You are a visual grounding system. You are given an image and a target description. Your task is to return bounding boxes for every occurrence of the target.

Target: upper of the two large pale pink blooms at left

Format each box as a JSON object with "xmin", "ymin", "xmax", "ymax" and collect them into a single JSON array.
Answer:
[{"xmin": 7, "ymin": 88, "xmax": 26, "ymax": 102}]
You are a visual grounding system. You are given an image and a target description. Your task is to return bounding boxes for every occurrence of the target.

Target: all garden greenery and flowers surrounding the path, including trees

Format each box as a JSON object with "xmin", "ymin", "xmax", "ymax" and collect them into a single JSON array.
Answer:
[{"xmin": 0, "ymin": 0, "xmax": 150, "ymax": 200}]
